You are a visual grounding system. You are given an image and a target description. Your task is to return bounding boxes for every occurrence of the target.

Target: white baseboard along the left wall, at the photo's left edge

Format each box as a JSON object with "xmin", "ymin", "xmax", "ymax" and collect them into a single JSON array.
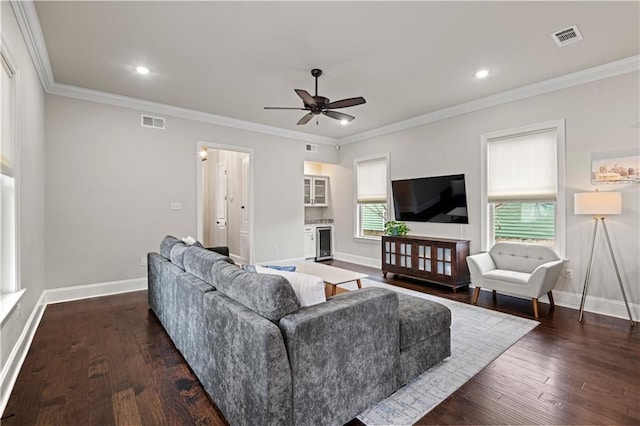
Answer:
[{"xmin": 0, "ymin": 293, "xmax": 46, "ymax": 415}]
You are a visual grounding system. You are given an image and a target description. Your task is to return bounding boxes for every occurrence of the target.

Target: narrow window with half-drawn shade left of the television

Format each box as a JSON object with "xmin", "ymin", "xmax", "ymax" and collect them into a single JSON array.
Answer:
[{"xmin": 354, "ymin": 154, "xmax": 389, "ymax": 238}]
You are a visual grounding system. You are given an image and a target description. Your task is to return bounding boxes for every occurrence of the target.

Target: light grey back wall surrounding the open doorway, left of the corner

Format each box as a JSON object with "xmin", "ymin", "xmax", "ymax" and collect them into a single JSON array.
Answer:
[{"xmin": 46, "ymin": 95, "xmax": 336, "ymax": 288}]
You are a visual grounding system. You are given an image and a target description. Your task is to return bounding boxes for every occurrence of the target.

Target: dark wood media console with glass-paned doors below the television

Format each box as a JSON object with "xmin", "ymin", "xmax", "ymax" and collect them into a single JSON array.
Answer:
[{"xmin": 382, "ymin": 235, "xmax": 470, "ymax": 291}]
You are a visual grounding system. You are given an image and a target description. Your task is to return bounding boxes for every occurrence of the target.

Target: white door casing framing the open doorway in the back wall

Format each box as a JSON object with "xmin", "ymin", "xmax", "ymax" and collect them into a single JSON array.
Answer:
[{"xmin": 195, "ymin": 141, "xmax": 255, "ymax": 264}]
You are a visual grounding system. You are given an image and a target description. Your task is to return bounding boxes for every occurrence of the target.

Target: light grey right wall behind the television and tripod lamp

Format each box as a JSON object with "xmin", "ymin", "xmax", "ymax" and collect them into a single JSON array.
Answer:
[{"xmin": 332, "ymin": 72, "xmax": 640, "ymax": 312}]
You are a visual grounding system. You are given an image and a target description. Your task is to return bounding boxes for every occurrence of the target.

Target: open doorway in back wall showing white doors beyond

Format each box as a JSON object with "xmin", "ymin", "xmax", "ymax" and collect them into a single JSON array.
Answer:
[{"xmin": 196, "ymin": 141, "xmax": 253, "ymax": 263}]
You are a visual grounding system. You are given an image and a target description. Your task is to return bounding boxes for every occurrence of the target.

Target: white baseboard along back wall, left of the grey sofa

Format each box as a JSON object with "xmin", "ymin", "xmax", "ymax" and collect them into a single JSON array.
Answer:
[{"xmin": 43, "ymin": 277, "xmax": 147, "ymax": 305}]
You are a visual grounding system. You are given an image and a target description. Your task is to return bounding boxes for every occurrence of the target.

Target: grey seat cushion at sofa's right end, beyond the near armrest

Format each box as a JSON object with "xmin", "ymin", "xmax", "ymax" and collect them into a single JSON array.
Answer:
[{"xmin": 398, "ymin": 293, "xmax": 451, "ymax": 351}]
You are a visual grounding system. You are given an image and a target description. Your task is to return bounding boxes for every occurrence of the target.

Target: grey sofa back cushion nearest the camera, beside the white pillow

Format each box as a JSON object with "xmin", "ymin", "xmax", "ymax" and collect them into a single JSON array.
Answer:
[{"xmin": 213, "ymin": 262, "xmax": 300, "ymax": 322}]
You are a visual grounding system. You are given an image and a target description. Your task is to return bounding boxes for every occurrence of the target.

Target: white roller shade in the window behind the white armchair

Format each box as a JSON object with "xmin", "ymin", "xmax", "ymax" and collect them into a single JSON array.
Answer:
[{"xmin": 487, "ymin": 129, "xmax": 558, "ymax": 203}]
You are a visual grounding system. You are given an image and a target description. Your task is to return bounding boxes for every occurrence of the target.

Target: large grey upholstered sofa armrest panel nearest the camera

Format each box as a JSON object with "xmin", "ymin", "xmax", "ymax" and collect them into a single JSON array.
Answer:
[{"xmin": 279, "ymin": 288, "xmax": 400, "ymax": 425}]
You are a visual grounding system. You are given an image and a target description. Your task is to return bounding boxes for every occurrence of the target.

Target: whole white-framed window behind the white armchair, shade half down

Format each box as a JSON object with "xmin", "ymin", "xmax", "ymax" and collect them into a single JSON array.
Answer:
[{"xmin": 482, "ymin": 121, "xmax": 564, "ymax": 255}]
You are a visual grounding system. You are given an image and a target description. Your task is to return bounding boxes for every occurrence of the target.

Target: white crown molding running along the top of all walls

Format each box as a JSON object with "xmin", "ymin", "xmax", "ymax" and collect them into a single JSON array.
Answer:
[{"xmin": 10, "ymin": 0, "xmax": 640, "ymax": 145}]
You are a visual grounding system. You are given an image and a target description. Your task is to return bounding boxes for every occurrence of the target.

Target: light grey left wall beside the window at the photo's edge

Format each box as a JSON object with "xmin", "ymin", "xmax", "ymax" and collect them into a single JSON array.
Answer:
[{"xmin": 0, "ymin": 1, "xmax": 45, "ymax": 369}]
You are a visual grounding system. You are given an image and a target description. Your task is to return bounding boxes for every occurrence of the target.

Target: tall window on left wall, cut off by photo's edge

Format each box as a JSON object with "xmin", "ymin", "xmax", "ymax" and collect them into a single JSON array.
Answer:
[{"xmin": 0, "ymin": 40, "xmax": 18, "ymax": 294}]
